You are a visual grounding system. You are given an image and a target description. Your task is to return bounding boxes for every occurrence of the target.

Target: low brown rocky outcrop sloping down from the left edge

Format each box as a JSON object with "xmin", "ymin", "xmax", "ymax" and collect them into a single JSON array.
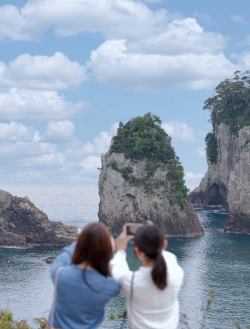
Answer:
[{"xmin": 0, "ymin": 190, "xmax": 78, "ymax": 246}]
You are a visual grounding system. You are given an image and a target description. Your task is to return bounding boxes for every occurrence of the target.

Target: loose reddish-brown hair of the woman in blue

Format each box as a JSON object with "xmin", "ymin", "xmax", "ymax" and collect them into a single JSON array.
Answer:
[{"xmin": 72, "ymin": 223, "xmax": 112, "ymax": 277}]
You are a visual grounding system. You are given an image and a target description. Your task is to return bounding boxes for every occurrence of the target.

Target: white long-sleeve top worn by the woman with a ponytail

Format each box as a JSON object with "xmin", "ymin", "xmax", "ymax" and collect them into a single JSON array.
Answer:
[{"xmin": 110, "ymin": 250, "xmax": 184, "ymax": 329}]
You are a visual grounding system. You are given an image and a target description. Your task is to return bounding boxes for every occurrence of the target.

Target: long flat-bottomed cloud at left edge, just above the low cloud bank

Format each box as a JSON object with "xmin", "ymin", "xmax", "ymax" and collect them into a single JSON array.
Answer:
[{"xmin": 0, "ymin": 88, "xmax": 90, "ymax": 121}]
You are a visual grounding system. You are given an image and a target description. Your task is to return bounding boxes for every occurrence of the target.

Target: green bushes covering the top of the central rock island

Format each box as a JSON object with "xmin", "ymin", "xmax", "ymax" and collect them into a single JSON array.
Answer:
[{"xmin": 108, "ymin": 113, "xmax": 188, "ymax": 209}]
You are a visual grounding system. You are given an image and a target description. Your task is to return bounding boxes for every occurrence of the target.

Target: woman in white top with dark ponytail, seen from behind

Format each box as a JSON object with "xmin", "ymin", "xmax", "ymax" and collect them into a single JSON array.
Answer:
[{"xmin": 111, "ymin": 225, "xmax": 183, "ymax": 329}]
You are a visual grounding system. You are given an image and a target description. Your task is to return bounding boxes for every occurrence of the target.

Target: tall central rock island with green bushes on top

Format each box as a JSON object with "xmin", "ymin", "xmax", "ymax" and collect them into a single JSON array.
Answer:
[{"xmin": 98, "ymin": 113, "xmax": 203, "ymax": 237}]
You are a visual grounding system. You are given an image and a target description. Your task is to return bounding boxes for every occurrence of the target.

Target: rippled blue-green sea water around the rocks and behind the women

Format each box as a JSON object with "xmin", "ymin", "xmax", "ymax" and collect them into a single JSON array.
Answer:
[{"xmin": 0, "ymin": 185, "xmax": 250, "ymax": 329}]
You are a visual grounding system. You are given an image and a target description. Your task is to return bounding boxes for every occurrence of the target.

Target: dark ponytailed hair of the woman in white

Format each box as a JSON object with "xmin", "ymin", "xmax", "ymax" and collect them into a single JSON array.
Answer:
[{"xmin": 134, "ymin": 225, "xmax": 167, "ymax": 290}]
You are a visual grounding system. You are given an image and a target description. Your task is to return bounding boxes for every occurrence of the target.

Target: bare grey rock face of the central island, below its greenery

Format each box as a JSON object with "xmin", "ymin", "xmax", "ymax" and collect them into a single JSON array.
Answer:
[{"xmin": 98, "ymin": 153, "xmax": 203, "ymax": 237}]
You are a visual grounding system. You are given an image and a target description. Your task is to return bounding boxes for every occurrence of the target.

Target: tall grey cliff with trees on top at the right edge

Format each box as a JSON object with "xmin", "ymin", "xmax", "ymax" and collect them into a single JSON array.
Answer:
[{"xmin": 190, "ymin": 72, "xmax": 250, "ymax": 234}]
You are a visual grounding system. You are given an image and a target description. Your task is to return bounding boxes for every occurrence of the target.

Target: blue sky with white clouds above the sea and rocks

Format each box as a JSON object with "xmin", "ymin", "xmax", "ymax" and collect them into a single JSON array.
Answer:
[{"xmin": 0, "ymin": 0, "xmax": 250, "ymax": 190}]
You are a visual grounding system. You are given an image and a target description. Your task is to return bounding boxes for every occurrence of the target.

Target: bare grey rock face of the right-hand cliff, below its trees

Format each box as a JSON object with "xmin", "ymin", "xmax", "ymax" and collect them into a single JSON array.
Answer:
[{"xmin": 190, "ymin": 123, "xmax": 250, "ymax": 233}]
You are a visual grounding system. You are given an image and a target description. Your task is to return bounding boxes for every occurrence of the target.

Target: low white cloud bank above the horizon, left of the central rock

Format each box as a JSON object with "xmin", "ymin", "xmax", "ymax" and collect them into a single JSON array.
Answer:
[{"xmin": 0, "ymin": 120, "xmax": 115, "ymax": 183}]
